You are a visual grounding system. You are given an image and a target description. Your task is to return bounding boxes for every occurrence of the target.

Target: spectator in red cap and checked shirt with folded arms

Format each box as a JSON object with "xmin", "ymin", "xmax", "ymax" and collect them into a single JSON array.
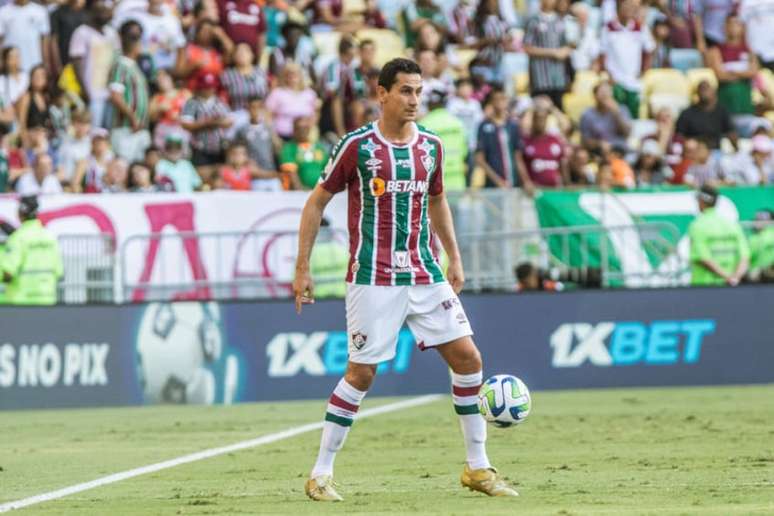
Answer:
[{"xmin": 178, "ymin": 74, "xmax": 233, "ymax": 181}]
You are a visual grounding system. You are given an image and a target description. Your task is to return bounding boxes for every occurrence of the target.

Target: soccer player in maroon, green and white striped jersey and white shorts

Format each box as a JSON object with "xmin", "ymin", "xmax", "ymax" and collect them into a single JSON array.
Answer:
[{"xmin": 293, "ymin": 58, "xmax": 517, "ymax": 501}]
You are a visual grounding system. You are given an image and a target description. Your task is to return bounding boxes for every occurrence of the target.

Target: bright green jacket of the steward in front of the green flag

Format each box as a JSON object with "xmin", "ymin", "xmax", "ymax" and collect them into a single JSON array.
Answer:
[{"xmin": 688, "ymin": 208, "xmax": 750, "ymax": 285}]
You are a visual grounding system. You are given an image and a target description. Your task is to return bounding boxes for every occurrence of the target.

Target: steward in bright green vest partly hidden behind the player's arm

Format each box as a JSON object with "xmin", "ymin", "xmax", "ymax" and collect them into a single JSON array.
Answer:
[{"xmin": 309, "ymin": 217, "xmax": 349, "ymax": 298}]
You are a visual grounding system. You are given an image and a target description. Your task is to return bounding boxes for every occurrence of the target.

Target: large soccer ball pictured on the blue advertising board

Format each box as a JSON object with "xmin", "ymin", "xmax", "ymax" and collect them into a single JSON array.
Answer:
[{"xmin": 136, "ymin": 303, "xmax": 223, "ymax": 405}]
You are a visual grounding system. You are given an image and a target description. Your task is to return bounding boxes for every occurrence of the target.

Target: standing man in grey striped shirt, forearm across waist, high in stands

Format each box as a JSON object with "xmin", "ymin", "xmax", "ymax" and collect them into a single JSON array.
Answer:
[{"xmin": 524, "ymin": 0, "xmax": 572, "ymax": 109}]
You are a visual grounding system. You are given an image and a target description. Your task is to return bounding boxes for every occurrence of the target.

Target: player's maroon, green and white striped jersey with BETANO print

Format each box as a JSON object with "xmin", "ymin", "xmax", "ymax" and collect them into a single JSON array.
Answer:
[{"xmin": 320, "ymin": 122, "xmax": 445, "ymax": 285}]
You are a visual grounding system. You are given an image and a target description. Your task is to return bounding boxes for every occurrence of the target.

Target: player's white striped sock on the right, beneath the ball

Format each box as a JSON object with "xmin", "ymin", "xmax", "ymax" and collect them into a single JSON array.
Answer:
[{"xmin": 451, "ymin": 371, "xmax": 492, "ymax": 469}]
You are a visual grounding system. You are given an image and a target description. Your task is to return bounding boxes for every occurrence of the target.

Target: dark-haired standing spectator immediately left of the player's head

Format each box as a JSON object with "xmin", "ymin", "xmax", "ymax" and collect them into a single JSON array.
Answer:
[{"xmin": 320, "ymin": 36, "xmax": 366, "ymax": 138}]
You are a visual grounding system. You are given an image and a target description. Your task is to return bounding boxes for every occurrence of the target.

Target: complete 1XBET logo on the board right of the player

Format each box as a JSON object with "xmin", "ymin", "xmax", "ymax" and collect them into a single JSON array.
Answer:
[{"xmin": 551, "ymin": 319, "xmax": 716, "ymax": 367}]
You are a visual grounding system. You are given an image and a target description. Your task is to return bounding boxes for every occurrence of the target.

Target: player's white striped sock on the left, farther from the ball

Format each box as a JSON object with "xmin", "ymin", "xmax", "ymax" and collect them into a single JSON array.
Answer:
[{"xmin": 311, "ymin": 378, "xmax": 366, "ymax": 478}]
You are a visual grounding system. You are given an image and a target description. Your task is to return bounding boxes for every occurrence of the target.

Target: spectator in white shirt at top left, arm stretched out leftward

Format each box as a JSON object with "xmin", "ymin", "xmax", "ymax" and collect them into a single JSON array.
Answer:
[{"xmin": 127, "ymin": 0, "xmax": 186, "ymax": 71}]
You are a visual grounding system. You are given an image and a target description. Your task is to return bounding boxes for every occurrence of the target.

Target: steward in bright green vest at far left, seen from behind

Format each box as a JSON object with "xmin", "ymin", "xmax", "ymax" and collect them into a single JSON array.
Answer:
[{"xmin": 0, "ymin": 196, "xmax": 64, "ymax": 305}]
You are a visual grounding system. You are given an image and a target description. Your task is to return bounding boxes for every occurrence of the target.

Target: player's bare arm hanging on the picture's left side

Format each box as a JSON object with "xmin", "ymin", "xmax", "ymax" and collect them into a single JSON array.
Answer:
[{"xmin": 293, "ymin": 185, "xmax": 333, "ymax": 313}]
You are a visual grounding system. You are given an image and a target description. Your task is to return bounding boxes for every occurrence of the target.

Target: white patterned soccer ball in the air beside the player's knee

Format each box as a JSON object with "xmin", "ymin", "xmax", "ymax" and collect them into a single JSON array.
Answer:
[{"xmin": 478, "ymin": 374, "xmax": 532, "ymax": 427}]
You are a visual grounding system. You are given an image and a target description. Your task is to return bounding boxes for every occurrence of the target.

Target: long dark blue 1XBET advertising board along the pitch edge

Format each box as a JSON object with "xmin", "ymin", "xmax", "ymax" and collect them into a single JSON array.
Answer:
[{"xmin": 0, "ymin": 286, "xmax": 774, "ymax": 409}]
